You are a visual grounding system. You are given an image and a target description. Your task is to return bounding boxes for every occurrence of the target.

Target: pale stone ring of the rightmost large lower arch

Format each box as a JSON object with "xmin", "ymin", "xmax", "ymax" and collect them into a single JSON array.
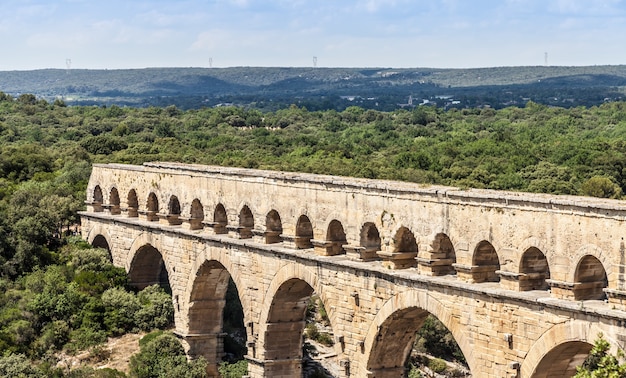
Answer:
[{"xmin": 520, "ymin": 320, "xmax": 619, "ymax": 378}]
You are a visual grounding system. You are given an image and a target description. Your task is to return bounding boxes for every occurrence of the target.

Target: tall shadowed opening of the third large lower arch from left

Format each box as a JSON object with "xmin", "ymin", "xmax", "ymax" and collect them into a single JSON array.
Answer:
[{"xmin": 188, "ymin": 260, "xmax": 247, "ymax": 363}]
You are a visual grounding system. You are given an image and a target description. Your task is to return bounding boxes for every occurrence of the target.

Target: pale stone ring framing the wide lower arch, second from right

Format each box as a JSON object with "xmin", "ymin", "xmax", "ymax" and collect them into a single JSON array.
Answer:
[{"xmin": 356, "ymin": 290, "xmax": 476, "ymax": 377}]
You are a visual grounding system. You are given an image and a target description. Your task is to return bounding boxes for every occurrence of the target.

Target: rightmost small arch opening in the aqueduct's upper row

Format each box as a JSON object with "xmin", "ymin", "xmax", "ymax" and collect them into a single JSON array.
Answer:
[{"xmin": 572, "ymin": 255, "xmax": 608, "ymax": 300}]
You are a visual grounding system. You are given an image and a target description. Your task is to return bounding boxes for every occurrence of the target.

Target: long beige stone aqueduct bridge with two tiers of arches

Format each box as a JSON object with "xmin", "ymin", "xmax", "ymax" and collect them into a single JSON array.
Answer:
[{"xmin": 81, "ymin": 163, "xmax": 626, "ymax": 378}]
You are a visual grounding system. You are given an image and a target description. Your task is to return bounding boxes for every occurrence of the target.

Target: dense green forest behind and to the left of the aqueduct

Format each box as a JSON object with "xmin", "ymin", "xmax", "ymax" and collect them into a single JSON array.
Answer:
[{"xmin": 0, "ymin": 92, "xmax": 626, "ymax": 377}]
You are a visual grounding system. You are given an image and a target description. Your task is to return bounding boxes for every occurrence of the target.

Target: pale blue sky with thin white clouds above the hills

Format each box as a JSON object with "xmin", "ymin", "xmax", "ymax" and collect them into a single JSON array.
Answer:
[{"xmin": 0, "ymin": 0, "xmax": 626, "ymax": 71}]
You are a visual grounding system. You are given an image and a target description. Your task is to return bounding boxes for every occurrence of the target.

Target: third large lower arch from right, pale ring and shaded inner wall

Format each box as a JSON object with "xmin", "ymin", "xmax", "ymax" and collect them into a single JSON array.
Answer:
[{"xmin": 254, "ymin": 264, "xmax": 336, "ymax": 377}]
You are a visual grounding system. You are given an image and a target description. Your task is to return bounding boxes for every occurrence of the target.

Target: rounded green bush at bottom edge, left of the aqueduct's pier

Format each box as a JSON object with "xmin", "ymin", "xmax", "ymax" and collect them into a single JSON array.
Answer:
[{"xmin": 130, "ymin": 333, "xmax": 206, "ymax": 378}]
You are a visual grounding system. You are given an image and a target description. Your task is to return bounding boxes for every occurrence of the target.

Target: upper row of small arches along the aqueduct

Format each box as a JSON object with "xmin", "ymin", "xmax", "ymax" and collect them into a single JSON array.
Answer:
[{"xmin": 91, "ymin": 185, "xmax": 608, "ymax": 300}]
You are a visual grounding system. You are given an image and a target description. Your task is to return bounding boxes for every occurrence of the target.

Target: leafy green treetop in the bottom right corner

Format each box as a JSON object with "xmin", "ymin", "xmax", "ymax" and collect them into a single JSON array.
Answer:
[{"xmin": 575, "ymin": 333, "xmax": 626, "ymax": 378}]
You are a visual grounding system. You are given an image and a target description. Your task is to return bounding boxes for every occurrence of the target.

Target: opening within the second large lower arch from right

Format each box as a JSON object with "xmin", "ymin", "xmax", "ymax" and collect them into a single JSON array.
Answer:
[{"xmin": 367, "ymin": 307, "xmax": 469, "ymax": 377}]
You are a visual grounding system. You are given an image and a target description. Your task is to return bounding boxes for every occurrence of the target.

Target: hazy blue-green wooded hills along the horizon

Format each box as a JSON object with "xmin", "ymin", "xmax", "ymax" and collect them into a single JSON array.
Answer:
[{"xmin": 0, "ymin": 65, "xmax": 626, "ymax": 110}]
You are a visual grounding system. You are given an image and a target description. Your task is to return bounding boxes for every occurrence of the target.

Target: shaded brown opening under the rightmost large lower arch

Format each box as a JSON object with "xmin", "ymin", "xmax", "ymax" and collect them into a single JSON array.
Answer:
[{"xmin": 532, "ymin": 341, "xmax": 593, "ymax": 378}]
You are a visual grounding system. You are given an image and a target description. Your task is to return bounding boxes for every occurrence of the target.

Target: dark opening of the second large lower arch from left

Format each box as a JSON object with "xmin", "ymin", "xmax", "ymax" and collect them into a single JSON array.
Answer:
[{"xmin": 128, "ymin": 244, "xmax": 172, "ymax": 294}]
